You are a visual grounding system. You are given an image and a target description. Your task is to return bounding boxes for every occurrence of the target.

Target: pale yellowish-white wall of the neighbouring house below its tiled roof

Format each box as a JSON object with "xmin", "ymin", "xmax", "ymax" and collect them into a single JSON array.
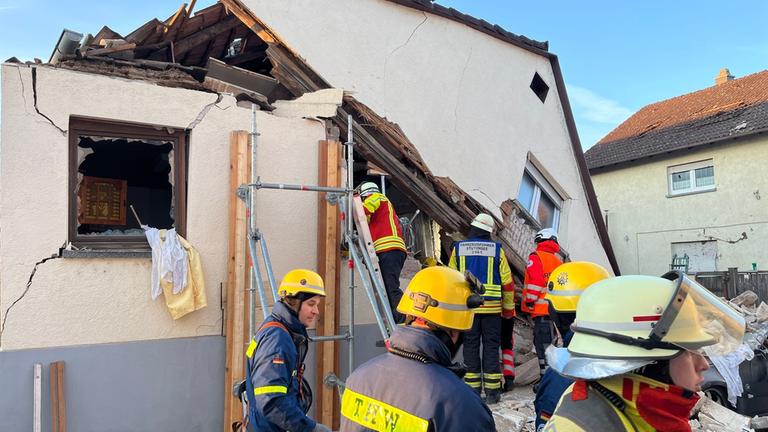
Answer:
[{"xmin": 592, "ymin": 138, "xmax": 768, "ymax": 275}]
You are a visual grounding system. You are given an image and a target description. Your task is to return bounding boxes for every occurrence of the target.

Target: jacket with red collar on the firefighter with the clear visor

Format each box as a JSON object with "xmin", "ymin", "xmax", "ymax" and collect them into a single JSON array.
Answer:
[{"xmin": 543, "ymin": 374, "xmax": 699, "ymax": 432}]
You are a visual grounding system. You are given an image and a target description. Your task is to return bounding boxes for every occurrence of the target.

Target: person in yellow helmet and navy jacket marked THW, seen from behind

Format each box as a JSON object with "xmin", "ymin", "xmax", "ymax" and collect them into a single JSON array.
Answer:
[{"xmin": 341, "ymin": 267, "xmax": 496, "ymax": 432}]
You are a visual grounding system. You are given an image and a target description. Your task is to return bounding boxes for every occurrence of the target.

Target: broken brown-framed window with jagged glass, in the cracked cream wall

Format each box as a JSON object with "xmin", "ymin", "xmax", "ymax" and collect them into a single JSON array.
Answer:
[{"xmin": 69, "ymin": 119, "xmax": 186, "ymax": 249}]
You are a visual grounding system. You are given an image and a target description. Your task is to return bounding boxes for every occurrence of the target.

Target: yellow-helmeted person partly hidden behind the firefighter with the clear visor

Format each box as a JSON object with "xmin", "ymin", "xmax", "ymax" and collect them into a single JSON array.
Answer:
[{"xmin": 533, "ymin": 261, "xmax": 610, "ymax": 431}]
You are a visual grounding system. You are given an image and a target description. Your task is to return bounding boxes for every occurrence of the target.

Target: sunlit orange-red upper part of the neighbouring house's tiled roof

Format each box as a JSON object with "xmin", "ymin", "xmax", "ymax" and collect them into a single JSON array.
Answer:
[{"xmin": 598, "ymin": 70, "xmax": 768, "ymax": 145}]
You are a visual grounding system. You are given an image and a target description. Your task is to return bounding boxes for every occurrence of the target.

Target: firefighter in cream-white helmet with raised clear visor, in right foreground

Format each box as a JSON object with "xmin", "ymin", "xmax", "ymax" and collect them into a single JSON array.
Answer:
[{"xmin": 544, "ymin": 271, "xmax": 745, "ymax": 432}]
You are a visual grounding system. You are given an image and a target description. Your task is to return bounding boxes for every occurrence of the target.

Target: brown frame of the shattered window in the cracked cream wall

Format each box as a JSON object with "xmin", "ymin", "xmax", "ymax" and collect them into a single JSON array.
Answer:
[{"xmin": 67, "ymin": 117, "xmax": 188, "ymax": 250}]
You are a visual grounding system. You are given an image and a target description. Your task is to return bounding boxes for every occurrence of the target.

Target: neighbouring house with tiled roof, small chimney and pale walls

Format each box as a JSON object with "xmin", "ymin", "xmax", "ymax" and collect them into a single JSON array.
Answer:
[{"xmin": 585, "ymin": 69, "xmax": 768, "ymax": 280}]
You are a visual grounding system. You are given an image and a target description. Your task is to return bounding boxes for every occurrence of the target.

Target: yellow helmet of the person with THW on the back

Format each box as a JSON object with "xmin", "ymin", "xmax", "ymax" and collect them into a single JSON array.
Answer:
[{"xmin": 397, "ymin": 267, "xmax": 483, "ymax": 331}]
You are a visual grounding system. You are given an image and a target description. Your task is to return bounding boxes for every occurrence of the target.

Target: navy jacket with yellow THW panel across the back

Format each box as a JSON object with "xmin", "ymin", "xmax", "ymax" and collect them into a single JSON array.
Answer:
[{"xmin": 341, "ymin": 325, "xmax": 496, "ymax": 432}]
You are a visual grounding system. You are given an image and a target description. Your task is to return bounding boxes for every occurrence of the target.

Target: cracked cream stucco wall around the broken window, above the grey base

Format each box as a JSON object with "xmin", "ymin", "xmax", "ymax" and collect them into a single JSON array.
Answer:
[{"xmin": 0, "ymin": 64, "xmax": 325, "ymax": 350}]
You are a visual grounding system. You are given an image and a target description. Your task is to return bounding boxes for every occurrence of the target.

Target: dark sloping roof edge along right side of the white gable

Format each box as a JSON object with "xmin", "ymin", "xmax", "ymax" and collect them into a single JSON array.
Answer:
[{"xmin": 547, "ymin": 53, "xmax": 621, "ymax": 276}]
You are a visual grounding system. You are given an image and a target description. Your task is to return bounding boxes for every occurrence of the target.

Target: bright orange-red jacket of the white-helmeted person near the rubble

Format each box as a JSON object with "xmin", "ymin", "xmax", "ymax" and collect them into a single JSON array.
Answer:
[{"xmin": 521, "ymin": 240, "xmax": 563, "ymax": 318}]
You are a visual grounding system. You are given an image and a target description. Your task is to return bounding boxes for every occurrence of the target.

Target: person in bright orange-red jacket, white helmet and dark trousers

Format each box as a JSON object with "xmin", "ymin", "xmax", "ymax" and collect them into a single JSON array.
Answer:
[{"xmin": 521, "ymin": 228, "xmax": 562, "ymax": 375}]
